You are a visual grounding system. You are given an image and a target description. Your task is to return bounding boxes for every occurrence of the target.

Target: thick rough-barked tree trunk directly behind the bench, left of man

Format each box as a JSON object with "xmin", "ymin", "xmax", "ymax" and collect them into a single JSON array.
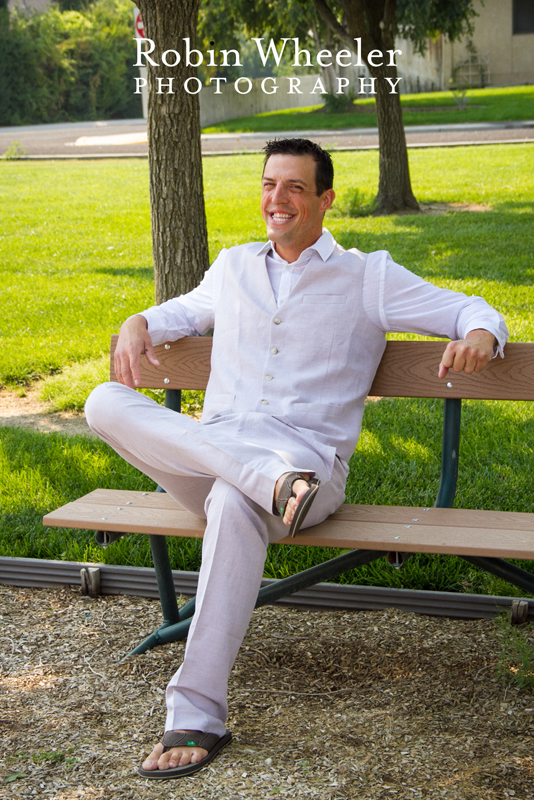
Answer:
[{"xmin": 137, "ymin": 0, "xmax": 209, "ymax": 303}]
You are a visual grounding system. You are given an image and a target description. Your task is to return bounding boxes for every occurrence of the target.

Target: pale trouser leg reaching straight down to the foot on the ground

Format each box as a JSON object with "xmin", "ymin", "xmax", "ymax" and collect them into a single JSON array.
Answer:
[{"xmin": 166, "ymin": 479, "xmax": 276, "ymax": 736}]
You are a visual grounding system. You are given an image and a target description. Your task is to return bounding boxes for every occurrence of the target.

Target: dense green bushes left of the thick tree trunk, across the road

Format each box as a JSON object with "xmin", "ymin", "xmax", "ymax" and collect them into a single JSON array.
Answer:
[{"xmin": 0, "ymin": 0, "xmax": 141, "ymax": 125}]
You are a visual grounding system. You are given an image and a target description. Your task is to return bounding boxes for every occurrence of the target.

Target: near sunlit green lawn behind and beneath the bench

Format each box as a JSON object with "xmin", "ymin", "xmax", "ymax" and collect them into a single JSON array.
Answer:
[{"xmin": 0, "ymin": 145, "xmax": 534, "ymax": 594}]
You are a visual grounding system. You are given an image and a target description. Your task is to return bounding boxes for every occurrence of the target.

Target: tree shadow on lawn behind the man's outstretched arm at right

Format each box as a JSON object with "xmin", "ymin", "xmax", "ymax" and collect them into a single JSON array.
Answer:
[{"xmin": 336, "ymin": 202, "xmax": 534, "ymax": 286}]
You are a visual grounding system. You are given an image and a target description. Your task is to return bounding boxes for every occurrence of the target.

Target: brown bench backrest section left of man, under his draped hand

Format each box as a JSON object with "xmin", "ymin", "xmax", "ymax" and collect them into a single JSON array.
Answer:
[{"xmin": 109, "ymin": 335, "xmax": 212, "ymax": 389}]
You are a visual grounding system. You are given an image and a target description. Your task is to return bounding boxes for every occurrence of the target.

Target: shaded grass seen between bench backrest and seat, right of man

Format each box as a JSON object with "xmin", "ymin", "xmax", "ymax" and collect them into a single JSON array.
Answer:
[{"xmin": 347, "ymin": 398, "xmax": 534, "ymax": 513}]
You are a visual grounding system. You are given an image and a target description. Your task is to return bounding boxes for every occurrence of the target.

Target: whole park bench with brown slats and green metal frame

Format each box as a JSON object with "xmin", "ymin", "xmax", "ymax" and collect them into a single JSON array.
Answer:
[{"xmin": 43, "ymin": 336, "xmax": 534, "ymax": 655}]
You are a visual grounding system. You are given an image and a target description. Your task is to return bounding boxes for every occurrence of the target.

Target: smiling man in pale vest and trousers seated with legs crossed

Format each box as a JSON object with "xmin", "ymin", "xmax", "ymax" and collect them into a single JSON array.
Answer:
[{"xmin": 86, "ymin": 139, "xmax": 507, "ymax": 779}]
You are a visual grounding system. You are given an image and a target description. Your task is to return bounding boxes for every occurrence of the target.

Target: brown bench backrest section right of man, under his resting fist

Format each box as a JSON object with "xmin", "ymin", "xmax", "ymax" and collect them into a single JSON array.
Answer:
[{"xmin": 369, "ymin": 341, "xmax": 534, "ymax": 400}]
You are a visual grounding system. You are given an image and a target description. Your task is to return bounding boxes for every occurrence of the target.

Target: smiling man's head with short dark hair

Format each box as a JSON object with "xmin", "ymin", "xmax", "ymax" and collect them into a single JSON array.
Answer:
[{"xmin": 261, "ymin": 139, "xmax": 335, "ymax": 261}]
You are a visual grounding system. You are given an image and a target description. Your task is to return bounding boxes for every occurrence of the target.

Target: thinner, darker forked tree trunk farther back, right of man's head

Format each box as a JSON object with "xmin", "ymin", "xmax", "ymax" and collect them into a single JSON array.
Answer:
[{"xmin": 314, "ymin": 0, "xmax": 419, "ymax": 214}]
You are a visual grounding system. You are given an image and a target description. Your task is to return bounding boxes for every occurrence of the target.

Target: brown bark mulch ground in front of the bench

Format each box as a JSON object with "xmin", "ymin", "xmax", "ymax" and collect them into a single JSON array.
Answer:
[{"xmin": 0, "ymin": 586, "xmax": 534, "ymax": 800}]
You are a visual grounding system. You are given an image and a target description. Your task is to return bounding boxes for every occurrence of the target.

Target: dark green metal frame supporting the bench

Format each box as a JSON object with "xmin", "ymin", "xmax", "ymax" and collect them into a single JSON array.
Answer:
[{"xmin": 120, "ymin": 389, "xmax": 534, "ymax": 658}]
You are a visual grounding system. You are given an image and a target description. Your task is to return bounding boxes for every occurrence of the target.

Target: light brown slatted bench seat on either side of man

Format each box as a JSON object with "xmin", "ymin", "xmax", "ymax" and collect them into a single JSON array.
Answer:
[{"xmin": 43, "ymin": 489, "xmax": 534, "ymax": 558}]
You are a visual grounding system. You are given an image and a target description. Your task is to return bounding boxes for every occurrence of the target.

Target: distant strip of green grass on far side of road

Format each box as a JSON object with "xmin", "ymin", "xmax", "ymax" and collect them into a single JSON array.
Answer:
[{"xmin": 203, "ymin": 86, "xmax": 534, "ymax": 133}]
